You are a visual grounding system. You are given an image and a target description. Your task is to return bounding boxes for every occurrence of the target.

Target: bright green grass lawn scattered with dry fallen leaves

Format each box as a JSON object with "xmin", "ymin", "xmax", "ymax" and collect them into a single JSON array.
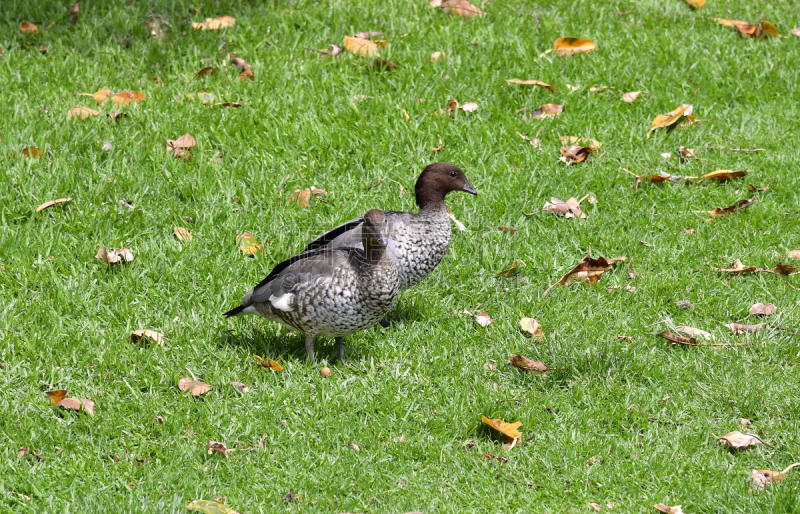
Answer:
[{"xmin": 0, "ymin": 0, "xmax": 800, "ymax": 513}]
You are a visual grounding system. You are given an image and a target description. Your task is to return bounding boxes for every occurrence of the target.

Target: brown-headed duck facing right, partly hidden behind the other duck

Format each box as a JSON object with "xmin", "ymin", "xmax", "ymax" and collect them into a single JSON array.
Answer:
[{"xmin": 304, "ymin": 162, "xmax": 478, "ymax": 289}]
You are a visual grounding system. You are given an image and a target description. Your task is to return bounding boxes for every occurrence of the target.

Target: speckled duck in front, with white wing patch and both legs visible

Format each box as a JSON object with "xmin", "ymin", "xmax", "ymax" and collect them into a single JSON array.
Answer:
[{"xmin": 224, "ymin": 209, "xmax": 400, "ymax": 362}]
